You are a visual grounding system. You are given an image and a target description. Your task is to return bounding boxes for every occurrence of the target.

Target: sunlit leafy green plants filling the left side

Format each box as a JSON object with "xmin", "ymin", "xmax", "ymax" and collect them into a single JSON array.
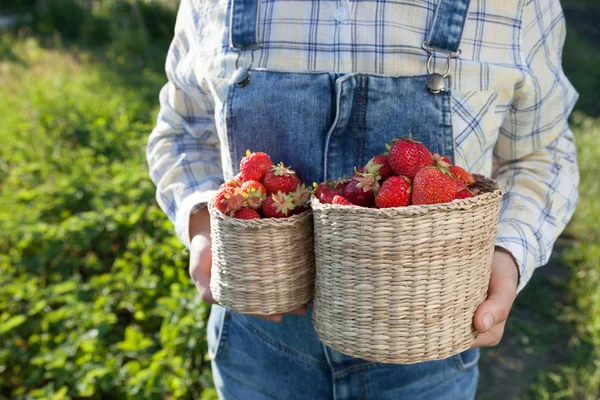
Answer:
[{"xmin": 0, "ymin": 39, "xmax": 214, "ymax": 399}]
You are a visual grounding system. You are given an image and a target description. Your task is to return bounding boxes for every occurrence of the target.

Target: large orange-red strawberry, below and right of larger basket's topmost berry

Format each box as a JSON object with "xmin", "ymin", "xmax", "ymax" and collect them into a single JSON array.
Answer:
[{"xmin": 412, "ymin": 167, "xmax": 456, "ymax": 204}]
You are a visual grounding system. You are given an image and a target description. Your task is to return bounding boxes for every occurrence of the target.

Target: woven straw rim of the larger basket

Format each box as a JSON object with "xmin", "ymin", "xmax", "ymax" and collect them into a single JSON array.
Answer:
[{"xmin": 310, "ymin": 174, "xmax": 504, "ymax": 216}]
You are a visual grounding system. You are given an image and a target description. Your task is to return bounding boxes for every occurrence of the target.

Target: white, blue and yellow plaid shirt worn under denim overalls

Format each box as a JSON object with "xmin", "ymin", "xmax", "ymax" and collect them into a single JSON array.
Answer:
[{"xmin": 147, "ymin": 0, "xmax": 579, "ymax": 290}]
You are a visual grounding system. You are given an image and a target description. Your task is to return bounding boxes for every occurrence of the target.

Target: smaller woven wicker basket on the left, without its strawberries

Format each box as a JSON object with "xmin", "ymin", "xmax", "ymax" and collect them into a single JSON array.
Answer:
[{"xmin": 209, "ymin": 204, "xmax": 315, "ymax": 315}]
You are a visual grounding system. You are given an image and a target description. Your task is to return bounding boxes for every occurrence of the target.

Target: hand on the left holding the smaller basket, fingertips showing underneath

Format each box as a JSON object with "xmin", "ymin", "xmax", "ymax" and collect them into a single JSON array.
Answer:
[{"xmin": 189, "ymin": 209, "xmax": 308, "ymax": 322}]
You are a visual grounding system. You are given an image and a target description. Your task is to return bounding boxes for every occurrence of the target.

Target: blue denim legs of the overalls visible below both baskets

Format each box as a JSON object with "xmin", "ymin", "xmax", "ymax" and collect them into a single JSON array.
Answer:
[{"xmin": 208, "ymin": 306, "xmax": 479, "ymax": 400}]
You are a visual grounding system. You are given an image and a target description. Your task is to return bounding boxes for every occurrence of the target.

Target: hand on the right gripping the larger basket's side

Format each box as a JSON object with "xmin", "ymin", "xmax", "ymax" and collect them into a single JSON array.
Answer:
[{"xmin": 471, "ymin": 247, "xmax": 519, "ymax": 348}]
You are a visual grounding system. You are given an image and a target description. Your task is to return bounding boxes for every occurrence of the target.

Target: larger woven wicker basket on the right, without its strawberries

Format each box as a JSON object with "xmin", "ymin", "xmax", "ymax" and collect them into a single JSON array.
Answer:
[{"xmin": 311, "ymin": 175, "xmax": 502, "ymax": 364}]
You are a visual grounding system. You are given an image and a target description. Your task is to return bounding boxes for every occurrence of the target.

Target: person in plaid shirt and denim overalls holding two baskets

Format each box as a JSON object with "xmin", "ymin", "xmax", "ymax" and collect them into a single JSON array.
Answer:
[{"xmin": 147, "ymin": 0, "xmax": 579, "ymax": 400}]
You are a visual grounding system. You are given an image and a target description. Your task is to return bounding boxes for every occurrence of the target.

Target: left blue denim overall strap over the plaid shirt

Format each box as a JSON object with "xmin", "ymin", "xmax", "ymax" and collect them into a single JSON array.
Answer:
[{"xmin": 229, "ymin": 0, "xmax": 260, "ymax": 51}]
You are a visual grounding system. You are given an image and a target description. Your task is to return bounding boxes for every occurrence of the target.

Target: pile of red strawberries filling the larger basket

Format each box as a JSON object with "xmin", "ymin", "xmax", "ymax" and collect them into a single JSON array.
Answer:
[{"xmin": 315, "ymin": 137, "xmax": 479, "ymax": 208}]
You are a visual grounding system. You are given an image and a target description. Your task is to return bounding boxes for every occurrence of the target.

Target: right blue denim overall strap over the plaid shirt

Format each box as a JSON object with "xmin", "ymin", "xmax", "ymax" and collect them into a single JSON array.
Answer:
[{"xmin": 427, "ymin": 0, "xmax": 470, "ymax": 53}]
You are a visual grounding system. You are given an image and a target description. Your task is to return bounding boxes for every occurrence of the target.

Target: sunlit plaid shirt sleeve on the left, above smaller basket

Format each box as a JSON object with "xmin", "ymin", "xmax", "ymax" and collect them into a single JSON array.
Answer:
[{"xmin": 146, "ymin": 0, "xmax": 223, "ymax": 246}]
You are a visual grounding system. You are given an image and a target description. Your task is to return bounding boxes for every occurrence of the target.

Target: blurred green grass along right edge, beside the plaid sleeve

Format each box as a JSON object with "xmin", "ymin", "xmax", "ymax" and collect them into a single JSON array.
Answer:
[{"xmin": 532, "ymin": 113, "xmax": 600, "ymax": 400}]
